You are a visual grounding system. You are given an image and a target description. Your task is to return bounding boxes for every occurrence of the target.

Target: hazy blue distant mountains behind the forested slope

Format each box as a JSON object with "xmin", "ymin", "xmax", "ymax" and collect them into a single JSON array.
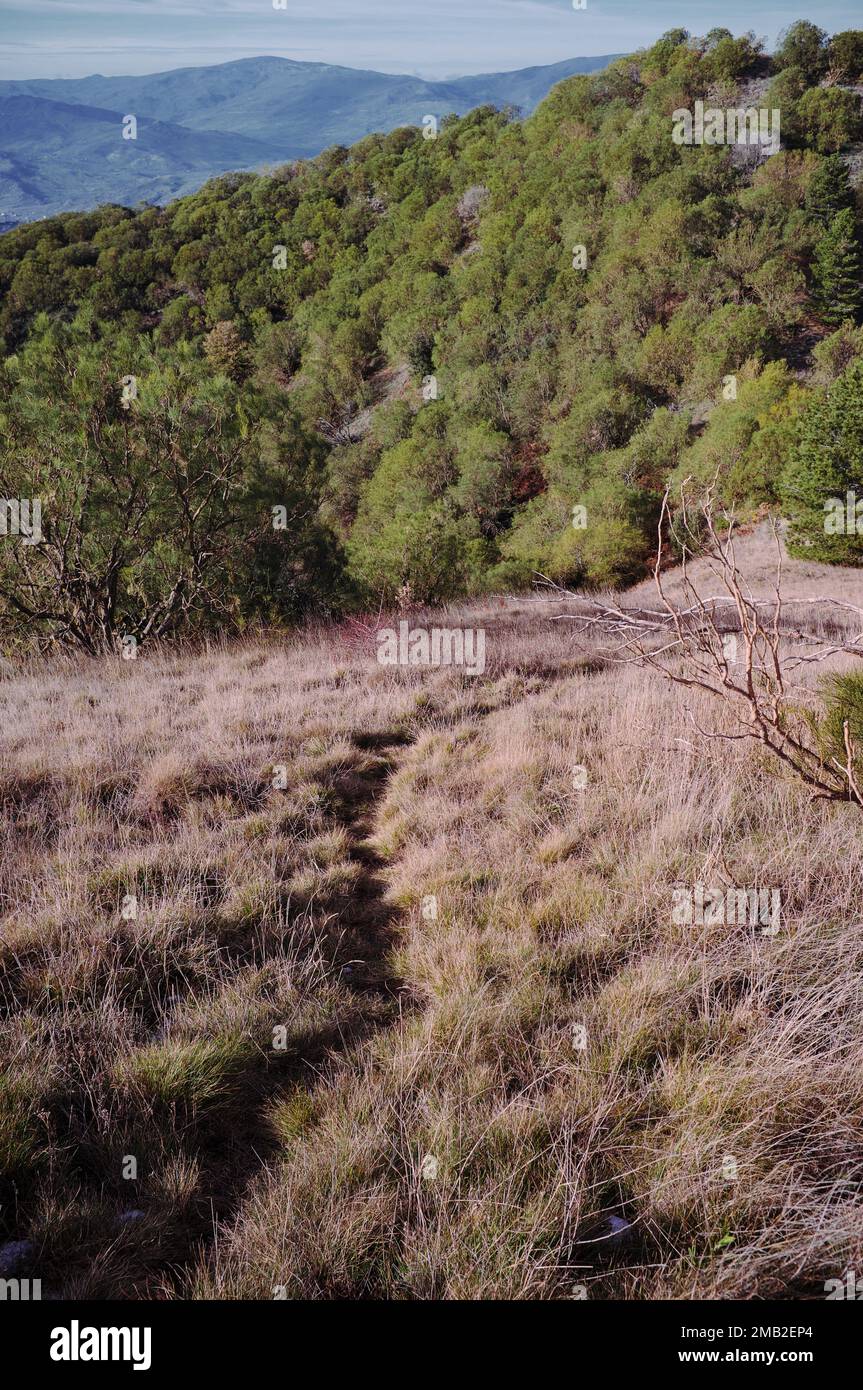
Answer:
[{"xmin": 0, "ymin": 54, "xmax": 617, "ymax": 225}]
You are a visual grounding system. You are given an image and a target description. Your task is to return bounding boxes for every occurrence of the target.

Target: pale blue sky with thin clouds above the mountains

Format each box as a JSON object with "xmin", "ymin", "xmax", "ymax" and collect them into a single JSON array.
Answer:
[{"xmin": 0, "ymin": 0, "xmax": 863, "ymax": 79}]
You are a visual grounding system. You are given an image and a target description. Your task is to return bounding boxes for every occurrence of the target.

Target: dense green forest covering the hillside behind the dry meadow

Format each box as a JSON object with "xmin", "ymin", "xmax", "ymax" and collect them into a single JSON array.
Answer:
[{"xmin": 0, "ymin": 22, "xmax": 863, "ymax": 649}]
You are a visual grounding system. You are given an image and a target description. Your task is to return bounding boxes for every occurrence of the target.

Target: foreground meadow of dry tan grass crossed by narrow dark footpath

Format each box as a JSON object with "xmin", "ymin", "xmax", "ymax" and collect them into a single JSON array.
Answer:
[{"xmin": 0, "ymin": 536, "xmax": 863, "ymax": 1298}]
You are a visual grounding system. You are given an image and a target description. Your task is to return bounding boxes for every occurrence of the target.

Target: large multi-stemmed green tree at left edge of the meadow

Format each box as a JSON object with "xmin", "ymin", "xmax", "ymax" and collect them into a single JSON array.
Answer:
[{"xmin": 0, "ymin": 313, "xmax": 340, "ymax": 652}]
